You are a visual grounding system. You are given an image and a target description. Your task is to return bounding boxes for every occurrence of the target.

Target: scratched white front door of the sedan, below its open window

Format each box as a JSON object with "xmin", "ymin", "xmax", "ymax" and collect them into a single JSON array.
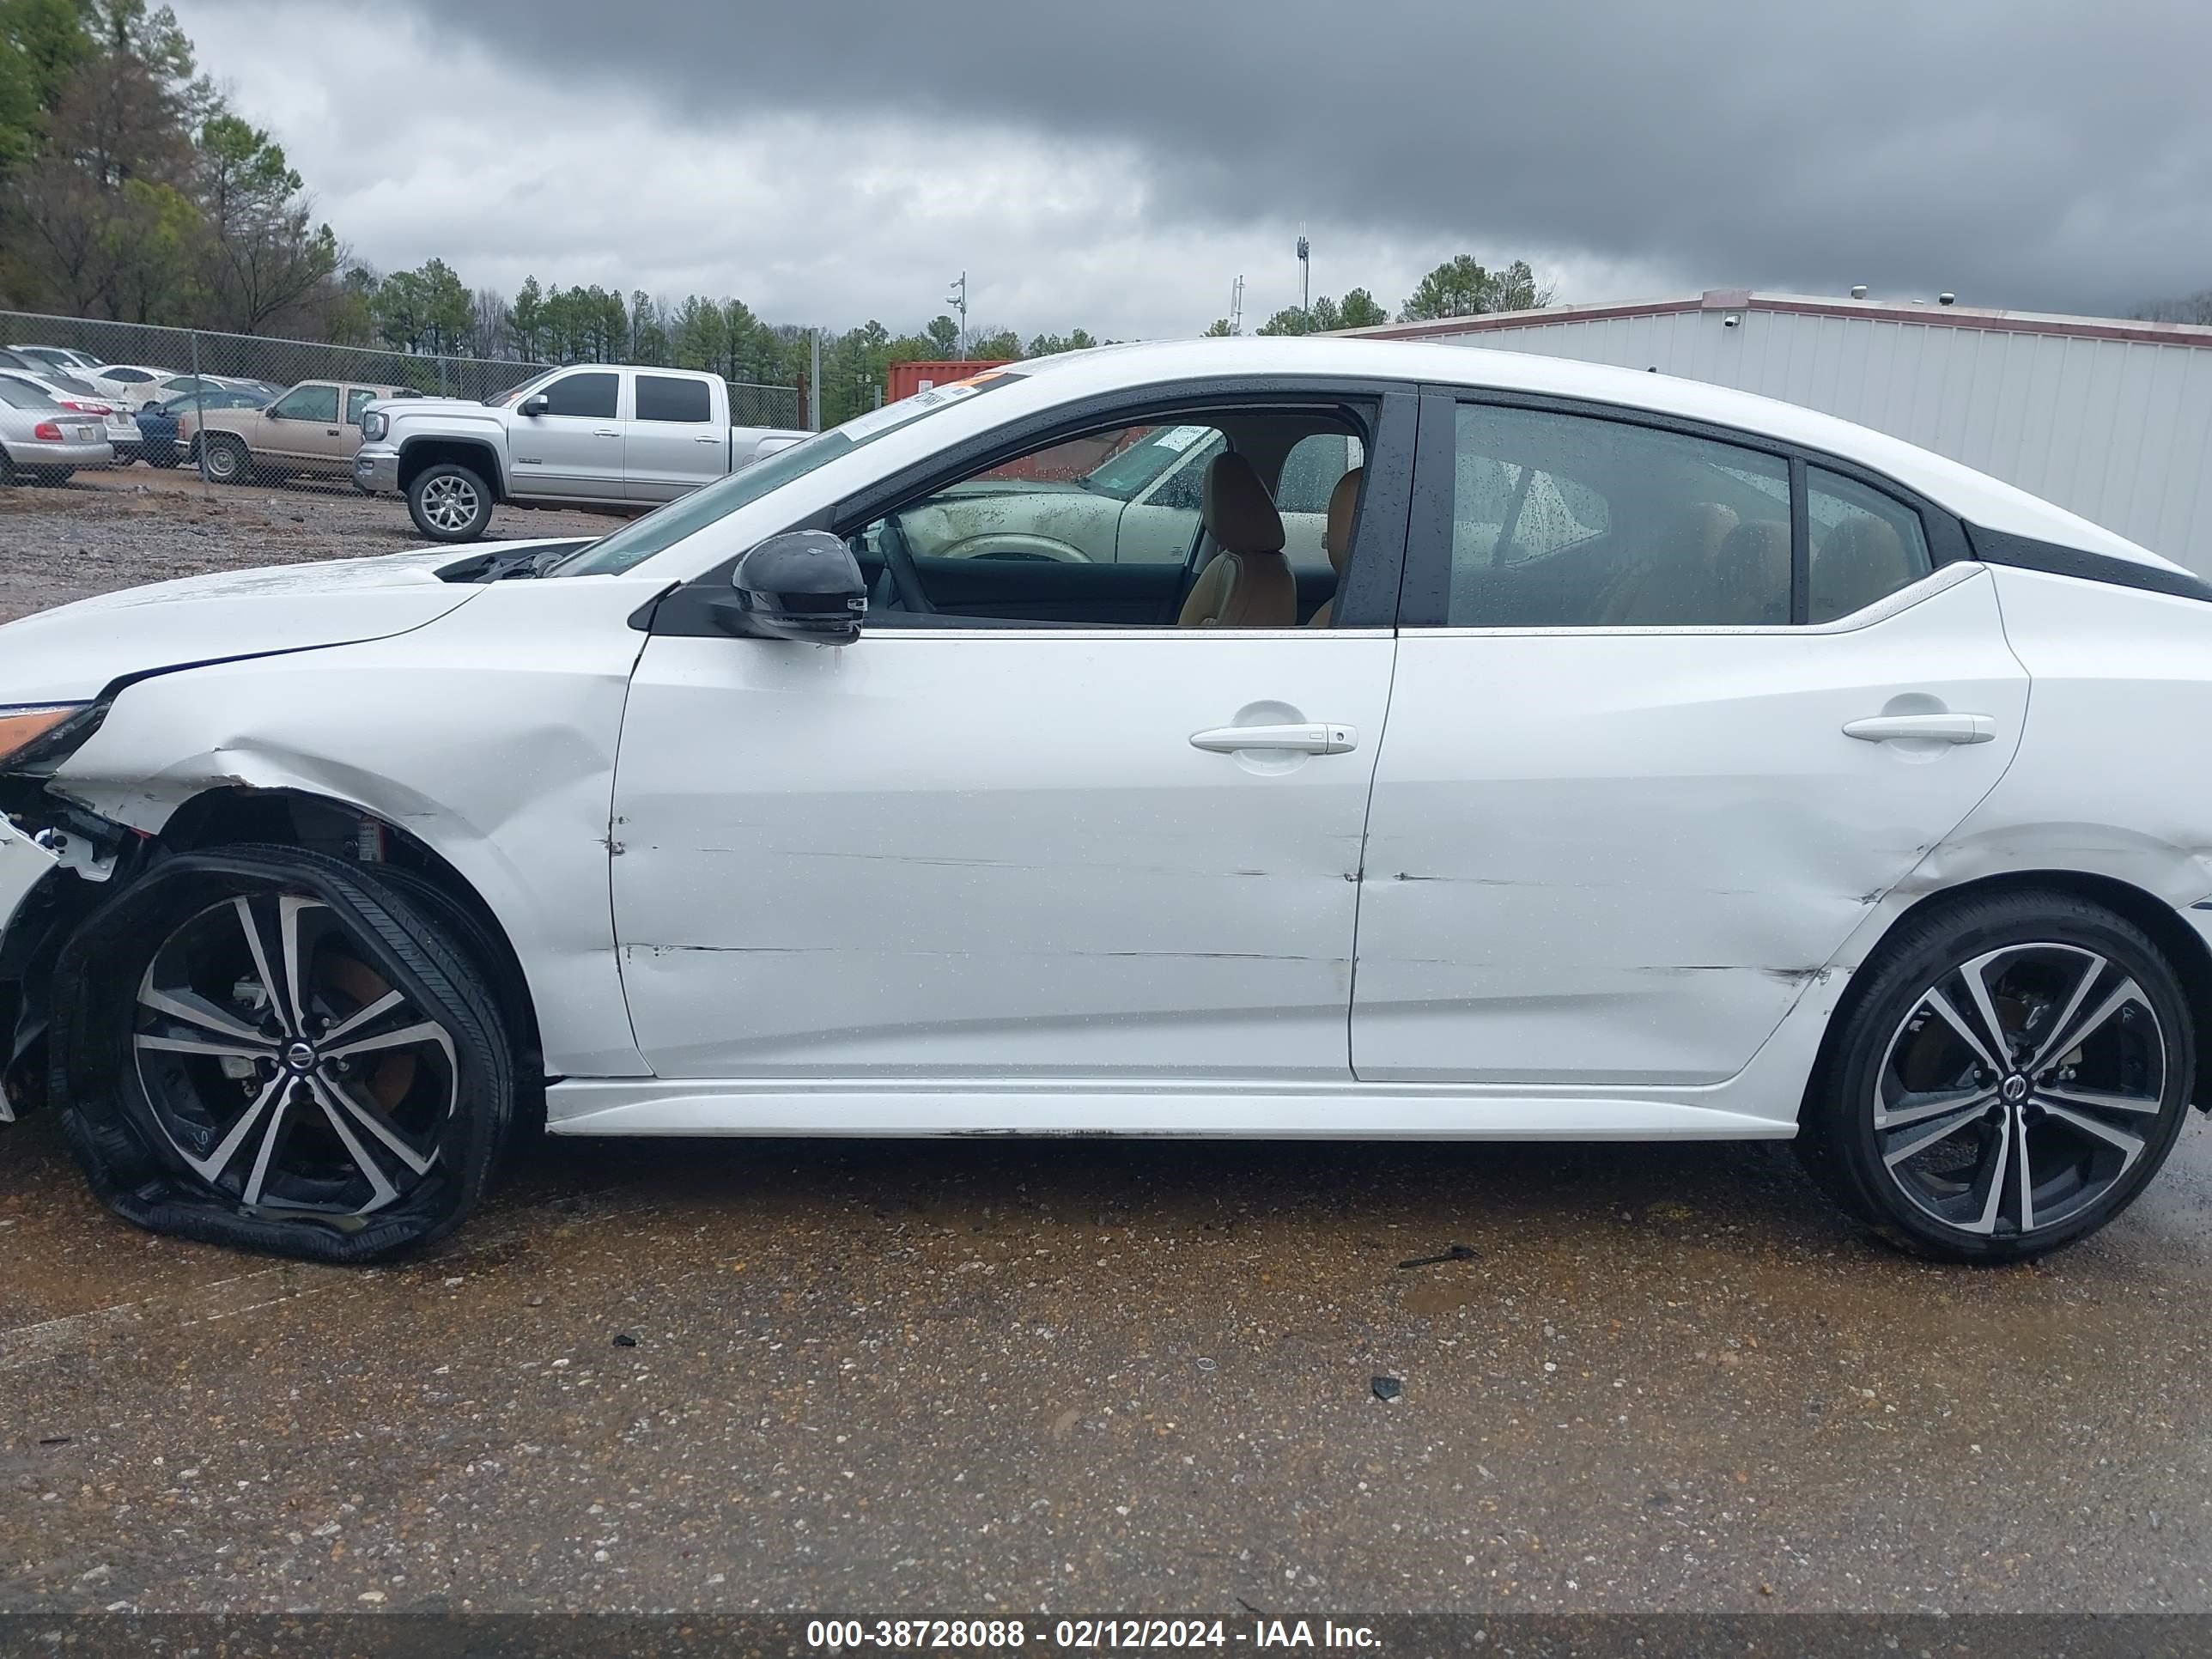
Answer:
[{"xmin": 613, "ymin": 389, "xmax": 1411, "ymax": 1130}]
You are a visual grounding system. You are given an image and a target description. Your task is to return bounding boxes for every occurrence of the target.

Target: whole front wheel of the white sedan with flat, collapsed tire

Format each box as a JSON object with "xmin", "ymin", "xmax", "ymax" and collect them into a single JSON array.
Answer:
[{"xmin": 49, "ymin": 848, "xmax": 515, "ymax": 1263}]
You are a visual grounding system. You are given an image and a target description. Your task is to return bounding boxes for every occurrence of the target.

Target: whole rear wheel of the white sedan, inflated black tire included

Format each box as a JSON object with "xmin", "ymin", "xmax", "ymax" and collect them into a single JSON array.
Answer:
[{"xmin": 1796, "ymin": 891, "xmax": 2197, "ymax": 1263}]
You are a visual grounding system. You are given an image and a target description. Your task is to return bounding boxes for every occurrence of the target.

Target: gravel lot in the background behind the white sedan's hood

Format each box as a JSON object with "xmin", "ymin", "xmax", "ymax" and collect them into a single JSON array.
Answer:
[{"xmin": 0, "ymin": 467, "xmax": 619, "ymax": 622}]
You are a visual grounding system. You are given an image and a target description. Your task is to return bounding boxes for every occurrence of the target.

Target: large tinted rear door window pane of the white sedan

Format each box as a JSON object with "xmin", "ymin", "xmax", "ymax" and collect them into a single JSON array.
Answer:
[{"xmin": 1447, "ymin": 404, "xmax": 1790, "ymax": 629}]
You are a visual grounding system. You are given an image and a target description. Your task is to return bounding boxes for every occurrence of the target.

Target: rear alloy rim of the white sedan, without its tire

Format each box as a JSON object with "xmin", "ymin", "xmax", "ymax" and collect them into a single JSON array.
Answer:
[{"xmin": 1871, "ymin": 942, "xmax": 2167, "ymax": 1239}]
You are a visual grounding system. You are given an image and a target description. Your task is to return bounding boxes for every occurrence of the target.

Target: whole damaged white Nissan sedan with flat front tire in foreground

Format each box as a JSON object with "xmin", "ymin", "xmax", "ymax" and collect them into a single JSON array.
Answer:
[{"xmin": 0, "ymin": 338, "xmax": 2212, "ymax": 1261}]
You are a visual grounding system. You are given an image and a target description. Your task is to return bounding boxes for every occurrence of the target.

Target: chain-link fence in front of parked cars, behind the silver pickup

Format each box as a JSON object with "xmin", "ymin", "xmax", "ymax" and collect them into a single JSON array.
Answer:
[{"xmin": 0, "ymin": 312, "xmax": 805, "ymax": 483}]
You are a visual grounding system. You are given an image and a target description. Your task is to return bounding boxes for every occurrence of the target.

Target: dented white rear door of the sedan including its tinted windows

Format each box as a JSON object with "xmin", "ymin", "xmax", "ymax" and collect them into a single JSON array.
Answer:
[{"xmin": 1352, "ymin": 403, "xmax": 2028, "ymax": 1086}]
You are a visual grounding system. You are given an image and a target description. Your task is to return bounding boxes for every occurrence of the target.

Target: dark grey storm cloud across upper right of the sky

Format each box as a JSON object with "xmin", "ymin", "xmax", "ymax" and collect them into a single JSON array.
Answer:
[{"xmin": 389, "ymin": 0, "xmax": 2212, "ymax": 310}]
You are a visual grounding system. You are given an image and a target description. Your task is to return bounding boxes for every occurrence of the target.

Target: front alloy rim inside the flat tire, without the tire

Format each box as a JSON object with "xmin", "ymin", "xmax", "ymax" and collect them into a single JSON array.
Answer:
[{"xmin": 133, "ymin": 891, "xmax": 460, "ymax": 1217}]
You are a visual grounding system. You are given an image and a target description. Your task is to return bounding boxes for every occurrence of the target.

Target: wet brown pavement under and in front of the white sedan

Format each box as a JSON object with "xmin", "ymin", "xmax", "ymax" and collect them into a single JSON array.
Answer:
[{"xmin": 0, "ymin": 1119, "xmax": 2212, "ymax": 1617}]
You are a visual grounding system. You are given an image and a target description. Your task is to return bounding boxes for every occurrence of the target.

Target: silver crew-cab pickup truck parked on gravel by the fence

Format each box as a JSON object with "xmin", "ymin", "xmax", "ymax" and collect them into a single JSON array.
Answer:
[{"xmin": 354, "ymin": 362, "xmax": 807, "ymax": 542}]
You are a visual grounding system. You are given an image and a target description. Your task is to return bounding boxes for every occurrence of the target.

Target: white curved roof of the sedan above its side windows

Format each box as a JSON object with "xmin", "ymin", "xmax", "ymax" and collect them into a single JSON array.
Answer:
[{"xmin": 1006, "ymin": 334, "xmax": 2184, "ymax": 571}]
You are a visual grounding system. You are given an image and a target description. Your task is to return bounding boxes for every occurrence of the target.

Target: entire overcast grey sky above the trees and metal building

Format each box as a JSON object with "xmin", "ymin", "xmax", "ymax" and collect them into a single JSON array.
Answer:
[{"xmin": 175, "ymin": 0, "xmax": 2212, "ymax": 337}]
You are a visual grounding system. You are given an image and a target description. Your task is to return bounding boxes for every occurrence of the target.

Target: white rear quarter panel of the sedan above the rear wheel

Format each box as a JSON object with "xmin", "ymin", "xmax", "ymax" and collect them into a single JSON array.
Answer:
[{"xmin": 1907, "ymin": 566, "xmax": 2212, "ymax": 907}]
